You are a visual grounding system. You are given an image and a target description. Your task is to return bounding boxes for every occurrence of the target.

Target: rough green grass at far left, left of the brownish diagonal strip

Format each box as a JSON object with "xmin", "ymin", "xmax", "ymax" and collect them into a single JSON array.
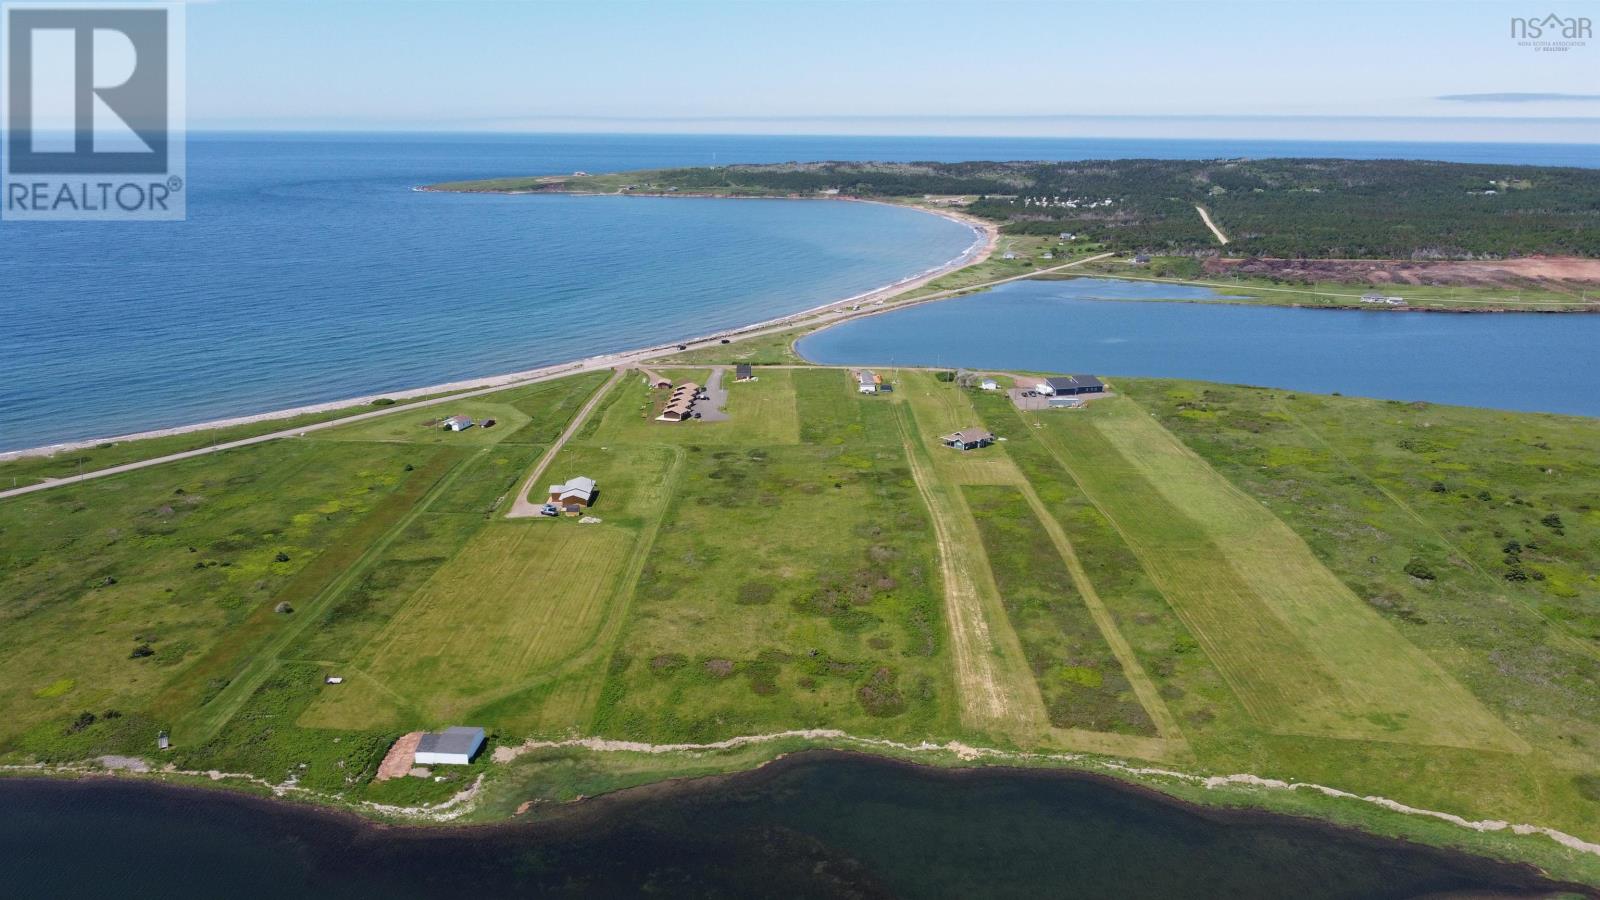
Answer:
[{"xmin": 0, "ymin": 442, "xmax": 427, "ymax": 749}]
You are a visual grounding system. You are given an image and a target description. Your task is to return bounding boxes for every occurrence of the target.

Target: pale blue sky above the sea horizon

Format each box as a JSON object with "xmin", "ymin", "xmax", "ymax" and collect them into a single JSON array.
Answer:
[{"xmin": 189, "ymin": 0, "xmax": 1600, "ymax": 143}]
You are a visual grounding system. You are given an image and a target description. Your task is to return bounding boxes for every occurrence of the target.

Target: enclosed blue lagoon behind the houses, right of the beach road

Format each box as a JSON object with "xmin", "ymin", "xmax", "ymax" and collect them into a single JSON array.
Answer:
[{"xmin": 798, "ymin": 279, "xmax": 1600, "ymax": 416}]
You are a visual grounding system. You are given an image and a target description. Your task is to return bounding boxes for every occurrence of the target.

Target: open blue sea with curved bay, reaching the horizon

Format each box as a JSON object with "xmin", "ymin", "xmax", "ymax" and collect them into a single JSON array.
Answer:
[{"xmin": 0, "ymin": 135, "xmax": 1600, "ymax": 450}]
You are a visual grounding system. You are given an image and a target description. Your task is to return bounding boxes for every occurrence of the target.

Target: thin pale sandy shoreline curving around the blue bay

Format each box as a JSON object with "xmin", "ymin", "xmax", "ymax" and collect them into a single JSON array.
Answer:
[{"xmin": 0, "ymin": 195, "xmax": 1000, "ymax": 461}]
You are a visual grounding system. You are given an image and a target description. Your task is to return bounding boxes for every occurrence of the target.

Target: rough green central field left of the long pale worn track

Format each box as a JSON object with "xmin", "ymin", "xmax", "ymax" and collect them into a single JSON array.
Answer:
[{"xmin": 592, "ymin": 370, "xmax": 952, "ymax": 740}]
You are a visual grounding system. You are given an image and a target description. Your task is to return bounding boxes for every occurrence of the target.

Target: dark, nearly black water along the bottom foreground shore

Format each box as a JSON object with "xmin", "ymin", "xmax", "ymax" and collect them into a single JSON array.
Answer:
[{"xmin": 0, "ymin": 753, "xmax": 1580, "ymax": 900}]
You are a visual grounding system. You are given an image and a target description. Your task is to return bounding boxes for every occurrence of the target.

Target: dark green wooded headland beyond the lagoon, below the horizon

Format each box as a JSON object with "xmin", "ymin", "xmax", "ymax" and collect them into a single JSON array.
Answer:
[{"xmin": 636, "ymin": 159, "xmax": 1600, "ymax": 258}]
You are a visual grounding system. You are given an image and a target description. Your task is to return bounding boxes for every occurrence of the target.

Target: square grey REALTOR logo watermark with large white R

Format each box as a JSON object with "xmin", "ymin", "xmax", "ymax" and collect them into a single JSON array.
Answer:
[{"xmin": 0, "ymin": 2, "xmax": 189, "ymax": 221}]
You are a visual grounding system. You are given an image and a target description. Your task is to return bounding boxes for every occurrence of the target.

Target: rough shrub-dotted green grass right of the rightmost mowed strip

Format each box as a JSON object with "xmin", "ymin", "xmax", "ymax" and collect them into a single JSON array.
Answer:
[{"xmin": 1118, "ymin": 380, "xmax": 1600, "ymax": 831}]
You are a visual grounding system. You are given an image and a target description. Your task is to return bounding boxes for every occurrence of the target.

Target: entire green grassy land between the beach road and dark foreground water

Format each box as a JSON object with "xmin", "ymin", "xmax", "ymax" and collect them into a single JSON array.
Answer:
[{"xmin": 0, "ymin": 367, "xmax": 1600, "ymax": 877}]
